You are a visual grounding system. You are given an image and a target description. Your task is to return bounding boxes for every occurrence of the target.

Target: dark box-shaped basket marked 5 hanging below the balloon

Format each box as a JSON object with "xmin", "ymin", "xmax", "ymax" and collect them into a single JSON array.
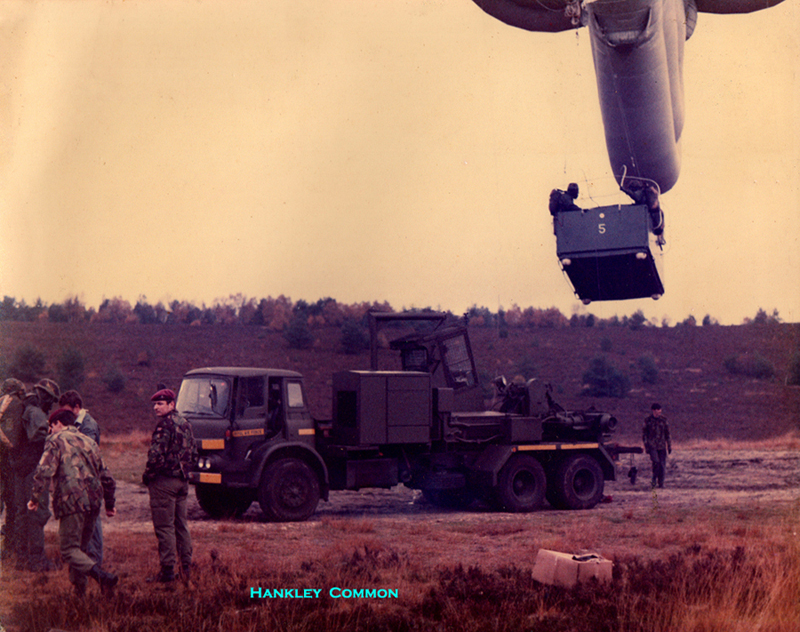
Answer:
[{"xmin": 553, "ymin": 204, "xmax": 664, "ymax": 303}]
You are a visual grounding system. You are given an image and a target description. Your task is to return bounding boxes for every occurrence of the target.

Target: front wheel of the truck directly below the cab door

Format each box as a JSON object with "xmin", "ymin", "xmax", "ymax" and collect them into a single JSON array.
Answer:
[{"xmin": 258, "ymin": 458, "xmax": 319, "ymax": 522}]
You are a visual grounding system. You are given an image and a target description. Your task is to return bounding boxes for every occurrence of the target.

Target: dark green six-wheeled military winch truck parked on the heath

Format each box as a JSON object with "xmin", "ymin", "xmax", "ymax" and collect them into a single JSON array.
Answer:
[{"xmin": 184, "ymin": 313, "xmax": 636, "ymax": 521}]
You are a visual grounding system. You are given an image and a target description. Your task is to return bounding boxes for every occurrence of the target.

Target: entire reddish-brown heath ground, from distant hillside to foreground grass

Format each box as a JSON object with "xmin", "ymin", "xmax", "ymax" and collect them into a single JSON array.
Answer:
[{"xmin": 0, "ymin": 322, "xmax": 800, "ymax": 632}]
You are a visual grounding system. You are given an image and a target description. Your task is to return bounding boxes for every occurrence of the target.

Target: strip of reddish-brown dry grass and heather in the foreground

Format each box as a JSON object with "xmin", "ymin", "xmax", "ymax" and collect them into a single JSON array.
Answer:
[{"xmin": 0, "ymin": 503, "xmax": 800, "ymax": 632}]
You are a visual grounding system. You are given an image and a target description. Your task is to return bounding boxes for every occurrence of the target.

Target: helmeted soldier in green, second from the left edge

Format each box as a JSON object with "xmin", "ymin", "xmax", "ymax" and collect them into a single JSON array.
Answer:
[{"xmin": 11, "ymin": 379, "xmax": 59, "ymax": 571}]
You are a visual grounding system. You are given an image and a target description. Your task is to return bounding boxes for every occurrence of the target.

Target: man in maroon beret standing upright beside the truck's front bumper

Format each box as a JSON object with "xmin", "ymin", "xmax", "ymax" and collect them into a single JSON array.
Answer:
[{"xmin": 142, "ymin": 388, "xmax": 197, "ymax": 583}]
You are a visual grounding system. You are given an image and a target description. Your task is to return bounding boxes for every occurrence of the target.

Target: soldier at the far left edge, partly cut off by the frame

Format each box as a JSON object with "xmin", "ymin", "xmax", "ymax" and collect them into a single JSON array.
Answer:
[{"xmin": 0, "ymin": 378, "xmax": 25, "ymax": 559}]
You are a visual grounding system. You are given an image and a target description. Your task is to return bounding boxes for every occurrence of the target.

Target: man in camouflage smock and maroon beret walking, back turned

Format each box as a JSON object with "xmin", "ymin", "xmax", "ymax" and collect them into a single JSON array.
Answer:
[{"xmin": 27, "ymin": 408, "xmax": 119, "ymax": 597}]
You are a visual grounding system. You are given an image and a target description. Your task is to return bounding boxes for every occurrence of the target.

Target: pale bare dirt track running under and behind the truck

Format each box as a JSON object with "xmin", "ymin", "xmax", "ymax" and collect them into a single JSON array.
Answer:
[{"xmin": 101, "ymin": 447, "xmax": 800, "ymax": 537}]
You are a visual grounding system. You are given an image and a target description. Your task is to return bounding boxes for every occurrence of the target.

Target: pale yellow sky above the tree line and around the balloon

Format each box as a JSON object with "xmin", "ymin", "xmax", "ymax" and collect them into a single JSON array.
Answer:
[{"xmin": 0, "ymin": 0, "xmax": 800, "ymax": 323}]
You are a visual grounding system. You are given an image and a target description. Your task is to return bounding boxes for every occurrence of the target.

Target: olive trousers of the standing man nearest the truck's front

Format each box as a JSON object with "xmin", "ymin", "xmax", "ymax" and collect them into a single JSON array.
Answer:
[{"xmin": 148, "ymin": 476, "xmax": 192, "ymax": 568}]
